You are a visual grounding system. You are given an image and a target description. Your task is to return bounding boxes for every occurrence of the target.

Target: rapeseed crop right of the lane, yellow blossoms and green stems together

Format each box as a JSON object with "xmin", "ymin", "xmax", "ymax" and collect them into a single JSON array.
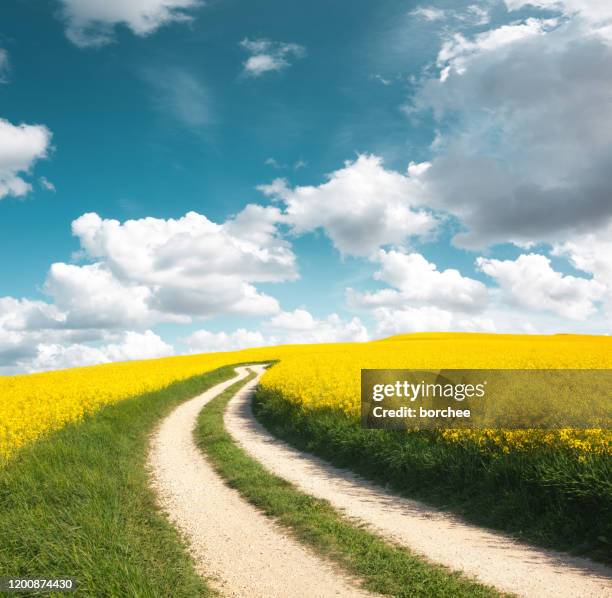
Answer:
[{"xmin": 256, "ymin": 334, "xmax": 612, "ymax": 561}]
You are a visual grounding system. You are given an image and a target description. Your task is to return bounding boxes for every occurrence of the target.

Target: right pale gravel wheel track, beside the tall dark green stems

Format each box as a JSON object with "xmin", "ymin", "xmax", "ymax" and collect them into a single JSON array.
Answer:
[{"xmin": 225, "ymin": 376, "xmax": 612, "ymax": 598}]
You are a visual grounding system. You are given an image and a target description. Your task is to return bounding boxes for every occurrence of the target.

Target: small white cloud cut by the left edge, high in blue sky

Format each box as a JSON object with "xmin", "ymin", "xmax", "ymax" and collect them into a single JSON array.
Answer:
[{"xmin": 0, "ymin": 119, "xmax": 51, "ymax": 200}]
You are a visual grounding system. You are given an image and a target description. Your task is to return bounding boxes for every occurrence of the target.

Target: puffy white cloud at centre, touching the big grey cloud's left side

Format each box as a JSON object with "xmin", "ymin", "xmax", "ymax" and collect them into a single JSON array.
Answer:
[{"xmin": 258, "ymin": 155, "xmax": 436, "ymax": 256}]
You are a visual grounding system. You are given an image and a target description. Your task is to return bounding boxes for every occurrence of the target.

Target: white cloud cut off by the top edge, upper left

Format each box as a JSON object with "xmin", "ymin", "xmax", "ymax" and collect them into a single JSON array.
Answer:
[{"xmin": 61, "ymin": 0, "xmax": 202, "ymax": 47}]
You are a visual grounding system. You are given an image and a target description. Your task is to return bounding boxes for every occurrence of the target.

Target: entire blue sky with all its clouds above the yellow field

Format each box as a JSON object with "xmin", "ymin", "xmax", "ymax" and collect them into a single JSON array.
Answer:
[{"xmin": 0, "ymin": 0, "xmax": 612, "ymax": 373}]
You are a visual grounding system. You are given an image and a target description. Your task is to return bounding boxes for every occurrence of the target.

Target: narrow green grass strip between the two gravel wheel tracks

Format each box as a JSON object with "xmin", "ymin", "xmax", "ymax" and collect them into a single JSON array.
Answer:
[{"xmin": 196, "ymin": 372, "xmax": 498, "ymax": 598}]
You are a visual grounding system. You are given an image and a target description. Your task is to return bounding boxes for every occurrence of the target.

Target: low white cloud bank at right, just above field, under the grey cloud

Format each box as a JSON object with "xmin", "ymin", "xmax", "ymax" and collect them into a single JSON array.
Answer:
[{"xmin": 347, "ymin": 246, "xmax": 612, "ymax": 336}]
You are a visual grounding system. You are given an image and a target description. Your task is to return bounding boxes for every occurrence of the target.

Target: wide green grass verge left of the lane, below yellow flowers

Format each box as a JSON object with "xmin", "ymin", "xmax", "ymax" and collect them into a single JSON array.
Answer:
[{"xmin": 0, "ymin": 367, "xmax": 244, "ymax": 598}]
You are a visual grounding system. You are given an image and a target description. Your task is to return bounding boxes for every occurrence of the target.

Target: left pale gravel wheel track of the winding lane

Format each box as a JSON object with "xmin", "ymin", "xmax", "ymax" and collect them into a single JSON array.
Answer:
[{"xmin": 149, "ymin": 366, "xmax": 371, "ymax": 598}]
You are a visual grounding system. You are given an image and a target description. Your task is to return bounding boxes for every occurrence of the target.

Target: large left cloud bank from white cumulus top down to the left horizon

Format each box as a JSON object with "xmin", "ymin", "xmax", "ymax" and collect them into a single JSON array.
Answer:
[{"xmin": 0, "ymin": 205, "xmax": 297, "ymax": 370}]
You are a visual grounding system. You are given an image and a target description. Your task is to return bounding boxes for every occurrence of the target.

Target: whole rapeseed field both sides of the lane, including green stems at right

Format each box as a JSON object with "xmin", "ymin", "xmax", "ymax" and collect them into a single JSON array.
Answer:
[{"xmin": 0, "ymin": 334, "xmax": 612, "ymax": 560}]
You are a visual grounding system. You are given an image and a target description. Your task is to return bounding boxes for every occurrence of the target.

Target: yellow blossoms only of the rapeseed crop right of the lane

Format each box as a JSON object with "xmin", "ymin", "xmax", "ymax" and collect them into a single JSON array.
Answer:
[{"xmin": 262, "ymin": 333, "xmax": 612, "ymax": 461}]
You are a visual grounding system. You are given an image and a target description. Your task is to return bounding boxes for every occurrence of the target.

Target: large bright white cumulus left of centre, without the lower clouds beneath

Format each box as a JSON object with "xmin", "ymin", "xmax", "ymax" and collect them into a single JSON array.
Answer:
[{"xmin": 66, "ymin": 211, "xmax": 297, "ymax": 324}]
